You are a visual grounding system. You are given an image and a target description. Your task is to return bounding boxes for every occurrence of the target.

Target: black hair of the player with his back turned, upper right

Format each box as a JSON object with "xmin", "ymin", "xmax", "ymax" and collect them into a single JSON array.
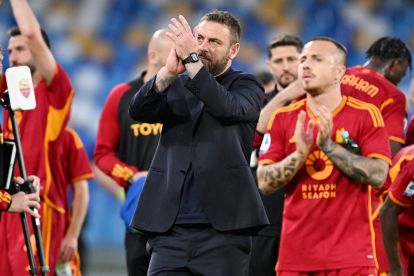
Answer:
[{"xmin": 365, "ymin": 36, "xmax": 411, "ymax": 70}]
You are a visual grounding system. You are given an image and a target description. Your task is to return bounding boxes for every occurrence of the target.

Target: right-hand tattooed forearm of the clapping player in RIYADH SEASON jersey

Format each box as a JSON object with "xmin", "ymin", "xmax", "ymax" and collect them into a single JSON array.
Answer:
[{"xmin": 321, "ymin": 140, "xmax": 388, "ymax": 188}]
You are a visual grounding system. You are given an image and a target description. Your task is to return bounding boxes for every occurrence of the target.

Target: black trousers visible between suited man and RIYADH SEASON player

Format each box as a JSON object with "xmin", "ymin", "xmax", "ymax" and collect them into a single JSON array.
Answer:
[{"xmin": 249, "ymin": 236, "xmax": 280, "ymax": 276}]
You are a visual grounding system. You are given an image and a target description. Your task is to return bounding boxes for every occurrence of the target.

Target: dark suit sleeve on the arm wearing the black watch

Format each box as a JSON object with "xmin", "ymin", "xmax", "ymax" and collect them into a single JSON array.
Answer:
[{"xmin": 186, "ymin": 67, "xmax": 264, "ymax": 123}]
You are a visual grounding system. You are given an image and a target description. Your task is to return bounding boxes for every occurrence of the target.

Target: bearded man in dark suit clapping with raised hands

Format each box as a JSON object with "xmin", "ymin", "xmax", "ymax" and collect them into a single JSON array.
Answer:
[{"xmin": 129, "ymin": 11, "xmax": 268, "ymax": 276}]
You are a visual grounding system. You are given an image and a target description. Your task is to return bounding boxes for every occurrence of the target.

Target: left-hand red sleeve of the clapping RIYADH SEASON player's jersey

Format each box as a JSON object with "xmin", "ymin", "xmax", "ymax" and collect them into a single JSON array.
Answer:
[{"xmin": 259, "ymin": 113, "xmax": 286, "ymax": 165}]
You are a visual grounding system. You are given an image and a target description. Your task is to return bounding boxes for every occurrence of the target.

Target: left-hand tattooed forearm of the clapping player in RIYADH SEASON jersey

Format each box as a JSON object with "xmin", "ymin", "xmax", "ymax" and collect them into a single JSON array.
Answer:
[{"xmin": 257, "ymin": 152, "xmax": 306, "ymax": 194}]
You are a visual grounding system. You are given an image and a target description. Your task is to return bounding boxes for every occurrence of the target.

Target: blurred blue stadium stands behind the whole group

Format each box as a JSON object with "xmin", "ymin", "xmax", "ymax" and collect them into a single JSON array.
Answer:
[{"xmin": 0, "ymin": 0, "xmax": 414, "ymax": 274}]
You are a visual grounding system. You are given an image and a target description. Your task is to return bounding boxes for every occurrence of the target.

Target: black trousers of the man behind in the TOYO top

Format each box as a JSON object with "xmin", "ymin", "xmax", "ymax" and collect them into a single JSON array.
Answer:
[{"xmin": 125, "ymin": 232, "xmax": 150, "ymax": 276}]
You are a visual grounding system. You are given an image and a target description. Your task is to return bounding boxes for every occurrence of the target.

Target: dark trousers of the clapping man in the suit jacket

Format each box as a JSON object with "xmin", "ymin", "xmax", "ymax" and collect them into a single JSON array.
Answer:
[{"xmin": 147, "ymin": 225, "xmax": 251, "ymax": 276}]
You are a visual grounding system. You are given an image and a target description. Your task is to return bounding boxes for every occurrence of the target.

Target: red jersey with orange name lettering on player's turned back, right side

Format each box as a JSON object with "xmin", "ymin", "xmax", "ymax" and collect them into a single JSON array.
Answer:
[{"xmin": 341, "ymin": 66, "xmax": 407, "ymax": 144}]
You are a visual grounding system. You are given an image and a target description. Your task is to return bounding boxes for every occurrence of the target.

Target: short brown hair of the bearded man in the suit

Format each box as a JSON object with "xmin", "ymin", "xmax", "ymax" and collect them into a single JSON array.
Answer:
[{"xmin": 200, "ymin": 10, "xmax": 241, "ymax": 44}]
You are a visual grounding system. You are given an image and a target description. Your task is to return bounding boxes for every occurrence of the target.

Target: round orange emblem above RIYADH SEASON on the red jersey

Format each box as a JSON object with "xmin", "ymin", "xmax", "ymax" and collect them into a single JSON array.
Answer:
[{"xmin": 305, "ymin": 150, "xmax": 333, "ymax": 180}]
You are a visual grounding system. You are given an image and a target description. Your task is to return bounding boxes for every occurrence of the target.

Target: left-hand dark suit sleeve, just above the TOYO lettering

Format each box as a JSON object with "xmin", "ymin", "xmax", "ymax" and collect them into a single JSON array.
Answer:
[{"xmin": 129, "ymin": 76, "xmax": 170, "ymax": 124}]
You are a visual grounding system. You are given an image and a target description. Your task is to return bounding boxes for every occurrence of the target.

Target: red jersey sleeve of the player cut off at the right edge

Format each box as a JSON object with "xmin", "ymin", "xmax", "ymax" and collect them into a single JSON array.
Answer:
[{"xmin": 388, "ymin": 160, "xmax": 414, "ymax": 207}]
